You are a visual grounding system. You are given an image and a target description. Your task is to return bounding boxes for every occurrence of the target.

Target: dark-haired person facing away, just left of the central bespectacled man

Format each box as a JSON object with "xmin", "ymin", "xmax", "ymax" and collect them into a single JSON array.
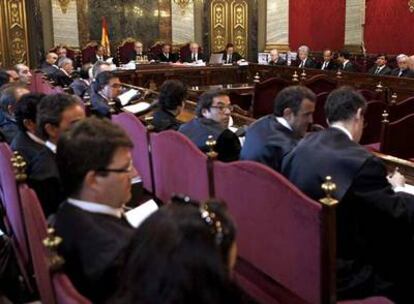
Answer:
[{"xmin": 152, "ymin": 79, "xmax": 187, "ymax": 132}]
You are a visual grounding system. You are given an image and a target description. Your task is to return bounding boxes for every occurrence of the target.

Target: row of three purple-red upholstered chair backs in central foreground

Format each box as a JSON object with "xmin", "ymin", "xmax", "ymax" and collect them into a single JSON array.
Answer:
[{"xmin": 113, "ymin": 113, "xmax": 389, "ymax": 303}]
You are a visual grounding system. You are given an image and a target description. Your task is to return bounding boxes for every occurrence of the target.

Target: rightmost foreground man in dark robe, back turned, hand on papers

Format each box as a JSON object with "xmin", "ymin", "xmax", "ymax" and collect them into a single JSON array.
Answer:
[{"xmin": 282, "ymin": 87, "xmax": 414, "ymax": 303}]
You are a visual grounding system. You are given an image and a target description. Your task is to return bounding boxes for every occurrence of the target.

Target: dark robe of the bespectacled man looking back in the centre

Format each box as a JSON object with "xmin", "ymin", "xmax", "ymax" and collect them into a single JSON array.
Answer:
[{"xmin": 179, "ymin": 118, "xmax": 241, "ymax": 162}]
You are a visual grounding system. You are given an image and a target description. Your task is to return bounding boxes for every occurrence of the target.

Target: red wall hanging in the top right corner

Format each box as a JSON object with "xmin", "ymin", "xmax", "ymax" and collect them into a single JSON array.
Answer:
[{"xmin": 365, "ymin": 0, "xmax": 414, "ymax": 54}]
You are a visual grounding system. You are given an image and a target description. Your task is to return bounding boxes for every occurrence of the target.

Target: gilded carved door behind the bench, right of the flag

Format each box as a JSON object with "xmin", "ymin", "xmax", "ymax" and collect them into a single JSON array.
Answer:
[{"xmin": 210, "ymin": 0, "xmax": 249, "ymax": 56}]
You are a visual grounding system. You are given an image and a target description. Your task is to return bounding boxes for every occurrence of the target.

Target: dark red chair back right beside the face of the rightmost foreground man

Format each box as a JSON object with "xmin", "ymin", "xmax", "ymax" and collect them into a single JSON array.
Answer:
[{"xmin": 360, "ymin": 100, "xmax": 388, "ymax": 145}]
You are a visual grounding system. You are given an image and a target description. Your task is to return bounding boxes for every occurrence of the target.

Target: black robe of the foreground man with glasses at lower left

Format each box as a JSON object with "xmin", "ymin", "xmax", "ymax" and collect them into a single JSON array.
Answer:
[{"xmin": 55, "ymin": 202, "xmax": 134, "ymax": 303}]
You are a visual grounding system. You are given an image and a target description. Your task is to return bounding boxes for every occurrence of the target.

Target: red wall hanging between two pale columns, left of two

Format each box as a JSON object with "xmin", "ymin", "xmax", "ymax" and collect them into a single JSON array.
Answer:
[{"xmin": 289, "ymin": 0, "xmax": 345, "ymax": 51}]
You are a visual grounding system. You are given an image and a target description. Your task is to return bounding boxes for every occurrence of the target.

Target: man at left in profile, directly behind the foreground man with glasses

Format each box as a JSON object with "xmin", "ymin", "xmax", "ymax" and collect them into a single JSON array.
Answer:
[{"xmin": 28, "ymin": 94, "xmax": 85, "ymax": 216}]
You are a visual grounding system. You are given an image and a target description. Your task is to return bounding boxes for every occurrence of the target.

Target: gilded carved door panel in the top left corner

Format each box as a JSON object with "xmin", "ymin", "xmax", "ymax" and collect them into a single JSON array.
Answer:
[{"xmin": 0, "ymin": 0, "xmax": 29, "ymax": 66}]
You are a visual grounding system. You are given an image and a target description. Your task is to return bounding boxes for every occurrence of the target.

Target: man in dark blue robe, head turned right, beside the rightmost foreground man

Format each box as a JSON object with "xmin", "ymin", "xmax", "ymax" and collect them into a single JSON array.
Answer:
[{"xmin": 240, "ymin": 86, "xmax": 316, "ymax": 171}]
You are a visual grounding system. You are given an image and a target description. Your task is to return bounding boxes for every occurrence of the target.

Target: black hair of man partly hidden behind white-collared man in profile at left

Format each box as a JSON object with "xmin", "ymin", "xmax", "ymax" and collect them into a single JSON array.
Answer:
[{"xmin": 14, "ymin": 93, "xmax": 46, "ymax": 131}]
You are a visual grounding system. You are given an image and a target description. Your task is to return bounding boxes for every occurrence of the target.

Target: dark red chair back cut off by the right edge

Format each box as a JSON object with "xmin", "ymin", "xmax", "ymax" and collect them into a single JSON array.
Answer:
[{"xmin": 380, "ymin": 114, "xmax": 414, "ymax": 159}]
